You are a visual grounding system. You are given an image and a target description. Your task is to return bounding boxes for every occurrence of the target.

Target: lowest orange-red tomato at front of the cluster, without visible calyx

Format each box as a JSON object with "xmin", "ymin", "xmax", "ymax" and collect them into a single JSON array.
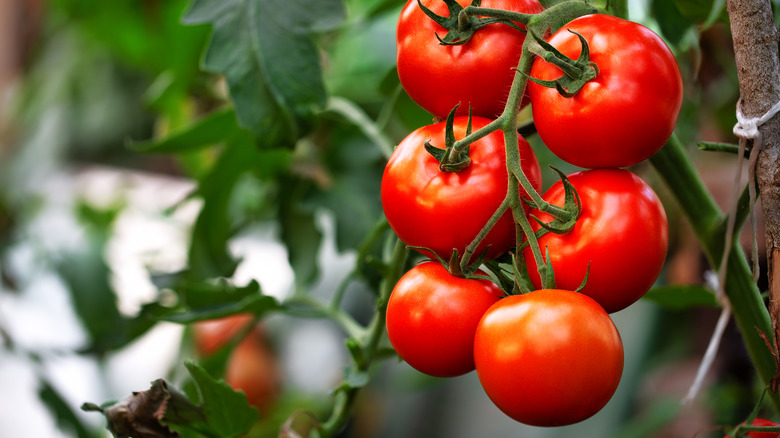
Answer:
[{"xmin": 474, "ymin": 289, "xmax": 623, "ymax": 426}]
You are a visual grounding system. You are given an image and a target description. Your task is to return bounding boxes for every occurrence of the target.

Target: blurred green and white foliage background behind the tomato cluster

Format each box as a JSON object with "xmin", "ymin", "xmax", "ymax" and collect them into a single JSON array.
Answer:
[{"xmin": 0, "ymin": 0, "xmax": 766, "ymax": 437}]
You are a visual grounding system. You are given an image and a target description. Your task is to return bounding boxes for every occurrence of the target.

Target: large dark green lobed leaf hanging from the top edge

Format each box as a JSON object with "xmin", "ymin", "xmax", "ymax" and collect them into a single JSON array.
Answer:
[{"xmin": 183, "ymin": 0, "xmax": 346, "ymax": 147}]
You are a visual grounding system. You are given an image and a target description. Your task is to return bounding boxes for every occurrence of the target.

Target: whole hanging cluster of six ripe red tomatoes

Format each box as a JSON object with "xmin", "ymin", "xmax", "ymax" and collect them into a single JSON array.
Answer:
[{"xmin": 381, "ymin": 0, "xmax": 682, "ymax": 426}]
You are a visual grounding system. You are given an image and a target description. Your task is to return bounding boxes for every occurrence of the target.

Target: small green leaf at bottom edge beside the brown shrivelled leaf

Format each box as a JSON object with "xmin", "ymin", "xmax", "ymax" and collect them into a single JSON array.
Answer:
[{"xmin": 184, "ymin": 361, "xmax": 260, "ymax": 437}]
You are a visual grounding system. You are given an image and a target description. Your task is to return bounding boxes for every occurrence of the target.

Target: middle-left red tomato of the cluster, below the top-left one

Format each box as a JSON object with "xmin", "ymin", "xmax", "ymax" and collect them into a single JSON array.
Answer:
[{"xmin": 381, "ymin": 116, "xmax": 542, "ymax": 260}]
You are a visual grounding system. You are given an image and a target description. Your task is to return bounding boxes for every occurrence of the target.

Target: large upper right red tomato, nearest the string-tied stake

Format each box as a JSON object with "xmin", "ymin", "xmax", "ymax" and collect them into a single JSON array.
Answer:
[{"xmin": 528, "ymin": 14, "xmax": 683, "ymax": 168}]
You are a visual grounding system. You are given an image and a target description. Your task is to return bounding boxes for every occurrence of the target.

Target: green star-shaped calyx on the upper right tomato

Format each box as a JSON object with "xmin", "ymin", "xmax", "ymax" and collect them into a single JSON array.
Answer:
[{"xmin": 526, "ymin": 30, "xmax": 599, "ymax": 97}]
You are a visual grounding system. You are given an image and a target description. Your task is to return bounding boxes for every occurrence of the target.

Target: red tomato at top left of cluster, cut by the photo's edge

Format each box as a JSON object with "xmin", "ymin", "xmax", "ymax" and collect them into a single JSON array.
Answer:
[{"xmin": 396, "ymin": 0, "xmax": 543, "ymax": 119}]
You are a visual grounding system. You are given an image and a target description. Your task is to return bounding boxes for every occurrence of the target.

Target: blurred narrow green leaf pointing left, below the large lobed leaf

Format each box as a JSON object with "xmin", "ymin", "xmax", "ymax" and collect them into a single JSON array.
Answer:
[{"xmin": 128, "ymin": 108, "xmax": 239, "ymax": 154}]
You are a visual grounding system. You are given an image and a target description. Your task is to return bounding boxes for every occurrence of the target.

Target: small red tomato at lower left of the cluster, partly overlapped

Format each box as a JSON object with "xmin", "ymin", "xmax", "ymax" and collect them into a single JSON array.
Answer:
[{"xmin": 387, "ymin": 261, "xmax": 503, "ymax": 377}]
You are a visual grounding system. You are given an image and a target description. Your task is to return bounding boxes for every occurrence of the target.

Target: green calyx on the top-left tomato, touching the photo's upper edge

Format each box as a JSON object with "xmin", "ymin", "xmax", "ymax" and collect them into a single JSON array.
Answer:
[{"xmin": 417, "ymin": 0, "xmax": 524, "ymax": 46}]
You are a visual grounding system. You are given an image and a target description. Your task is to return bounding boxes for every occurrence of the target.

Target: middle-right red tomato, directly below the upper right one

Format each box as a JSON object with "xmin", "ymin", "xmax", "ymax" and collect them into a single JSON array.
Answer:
[{"xmin": 523, "ymin": 169, "xmax": 669, "ymax": 313}]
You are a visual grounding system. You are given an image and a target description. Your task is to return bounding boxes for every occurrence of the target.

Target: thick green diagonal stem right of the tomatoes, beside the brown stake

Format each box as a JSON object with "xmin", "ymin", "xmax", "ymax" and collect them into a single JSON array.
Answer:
[{"xmin": 650, "ymin": 136, "xmax": 780, "ymax": 412}]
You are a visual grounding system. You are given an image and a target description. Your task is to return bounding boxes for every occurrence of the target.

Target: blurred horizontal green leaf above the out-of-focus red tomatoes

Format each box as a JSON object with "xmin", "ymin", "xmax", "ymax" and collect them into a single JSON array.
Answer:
[{"xmin": 143, "ymin": 280, "xmax": 281, "ymax": 324}]
